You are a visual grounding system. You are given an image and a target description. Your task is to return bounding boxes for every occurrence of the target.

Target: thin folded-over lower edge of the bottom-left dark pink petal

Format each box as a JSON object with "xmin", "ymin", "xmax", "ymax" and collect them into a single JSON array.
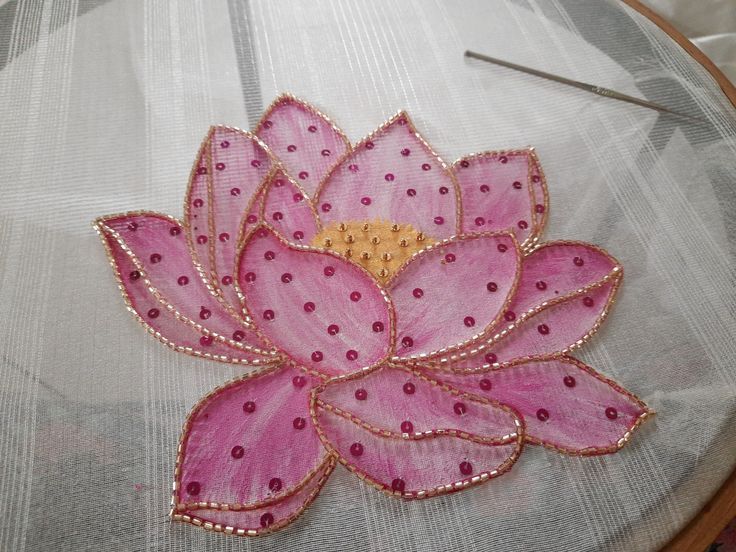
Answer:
[{"xmin": 172, "ymin": 458, "xmax": 335, "ymax": 536}]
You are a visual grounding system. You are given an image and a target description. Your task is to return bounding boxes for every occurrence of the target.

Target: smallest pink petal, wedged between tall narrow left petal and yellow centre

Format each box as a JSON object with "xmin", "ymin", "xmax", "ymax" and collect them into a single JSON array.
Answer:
[{"xmin": 262, "ymin": 170, "xmax": 319, "ymax": 244}]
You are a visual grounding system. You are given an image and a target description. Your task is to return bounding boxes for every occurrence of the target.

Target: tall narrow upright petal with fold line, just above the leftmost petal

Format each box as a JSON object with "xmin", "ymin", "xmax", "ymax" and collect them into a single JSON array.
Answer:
[{"xmin": 184, "ymin": 126, "xmax": 272, "ymax": 313}]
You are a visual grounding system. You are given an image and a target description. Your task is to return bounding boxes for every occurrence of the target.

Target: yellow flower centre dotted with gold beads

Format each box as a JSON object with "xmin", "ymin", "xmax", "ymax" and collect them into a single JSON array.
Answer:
[{"xmin": 312, "ymin": 220, "xmax": 436, "ymax": 282}]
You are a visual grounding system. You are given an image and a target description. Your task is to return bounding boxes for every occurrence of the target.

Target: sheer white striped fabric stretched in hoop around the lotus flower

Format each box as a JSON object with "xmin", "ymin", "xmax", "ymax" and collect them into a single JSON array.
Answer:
[{"xmin": 0, "ymin": 0, "xmax": 736, "ymax": 551}]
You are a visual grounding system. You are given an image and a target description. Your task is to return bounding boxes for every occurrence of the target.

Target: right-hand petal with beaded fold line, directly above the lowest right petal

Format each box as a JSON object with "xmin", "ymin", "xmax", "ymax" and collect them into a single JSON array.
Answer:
[{"xmin": 432, "ymin": 242, "xmax": 623, "ymax": 371}]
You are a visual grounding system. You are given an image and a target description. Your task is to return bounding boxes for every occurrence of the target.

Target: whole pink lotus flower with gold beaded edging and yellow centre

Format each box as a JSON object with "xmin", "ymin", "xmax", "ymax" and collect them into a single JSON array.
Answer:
[{"xmin": 96, "ymin": 96, "xmax": 650, "ymax": 535}]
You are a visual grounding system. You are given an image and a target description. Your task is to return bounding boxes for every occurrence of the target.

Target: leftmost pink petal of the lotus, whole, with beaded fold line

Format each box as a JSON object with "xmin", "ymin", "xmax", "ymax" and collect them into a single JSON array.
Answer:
[{"xmin": 96, "ymin": 212, "xmax": 275, "ymax": 364}]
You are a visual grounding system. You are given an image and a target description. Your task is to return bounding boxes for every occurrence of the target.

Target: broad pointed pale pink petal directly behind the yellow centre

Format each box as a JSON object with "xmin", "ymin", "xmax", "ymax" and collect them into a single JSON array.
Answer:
[{"xmin": 315, "ymin": 112, "xmax": 459, "ymax": 239}]
